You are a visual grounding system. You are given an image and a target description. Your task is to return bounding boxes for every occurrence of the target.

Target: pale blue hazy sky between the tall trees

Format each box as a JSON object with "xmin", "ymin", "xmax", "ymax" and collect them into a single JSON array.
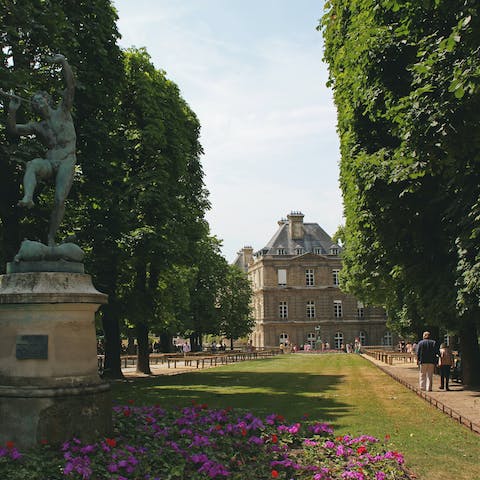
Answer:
[{"xmin": 114, "ymin": 0, "xmax": 342, "ymax": 261}]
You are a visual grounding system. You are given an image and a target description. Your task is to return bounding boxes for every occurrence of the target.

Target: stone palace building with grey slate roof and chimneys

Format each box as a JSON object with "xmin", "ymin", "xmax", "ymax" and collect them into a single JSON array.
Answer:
[{"xmin": 234, "ymin": 212, "xmax": 394, "ymax": 348}]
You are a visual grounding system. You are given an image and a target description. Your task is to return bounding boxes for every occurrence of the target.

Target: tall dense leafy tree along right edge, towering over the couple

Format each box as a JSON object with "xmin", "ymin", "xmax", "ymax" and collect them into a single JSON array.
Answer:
[{"xmin": 323, "ymin": 0, "xmax": 480, "ymax": 385}]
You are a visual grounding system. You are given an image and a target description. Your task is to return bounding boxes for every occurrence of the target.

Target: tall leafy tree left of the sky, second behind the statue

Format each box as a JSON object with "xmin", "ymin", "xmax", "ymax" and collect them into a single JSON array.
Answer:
[{"xmin": 116, "ymin": 49, "xmax": 208, "ymax": 373}]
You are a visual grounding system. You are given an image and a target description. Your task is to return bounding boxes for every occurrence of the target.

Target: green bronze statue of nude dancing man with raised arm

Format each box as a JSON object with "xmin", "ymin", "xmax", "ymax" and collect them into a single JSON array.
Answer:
[{"xmin": 8, "ymin": 54, "xmax": 77, "ymax": 246}]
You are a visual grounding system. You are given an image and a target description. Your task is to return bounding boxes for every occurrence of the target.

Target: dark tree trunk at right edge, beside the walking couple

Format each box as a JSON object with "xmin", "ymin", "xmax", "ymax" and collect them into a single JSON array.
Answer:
[{"xmin": 459, "ymin": 312, "xmax": 480, "ymax": 387}]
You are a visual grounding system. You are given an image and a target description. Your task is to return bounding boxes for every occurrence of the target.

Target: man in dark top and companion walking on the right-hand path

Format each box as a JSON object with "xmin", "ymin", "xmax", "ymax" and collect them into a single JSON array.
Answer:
[{"xmin": 416, "ymin": 332, "xmax": 454, "ymax": 392}]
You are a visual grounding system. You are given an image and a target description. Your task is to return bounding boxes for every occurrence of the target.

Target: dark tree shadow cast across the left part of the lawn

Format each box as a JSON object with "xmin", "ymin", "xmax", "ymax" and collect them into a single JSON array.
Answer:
[{"xmin": 112, "ymin": 368, "xmax": 350, "ymax": 427}]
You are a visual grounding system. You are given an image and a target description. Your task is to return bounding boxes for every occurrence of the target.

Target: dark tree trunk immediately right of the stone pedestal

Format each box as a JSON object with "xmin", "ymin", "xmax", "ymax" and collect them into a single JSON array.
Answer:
[{"xmin": 102, "ymin": 304, "xmax": 123, "ymax": 379}]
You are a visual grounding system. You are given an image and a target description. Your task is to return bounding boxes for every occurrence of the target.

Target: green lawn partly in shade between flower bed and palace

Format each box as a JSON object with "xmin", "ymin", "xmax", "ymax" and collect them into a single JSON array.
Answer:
[{"xmin": 113, "ymin": 354, "xmax": 480, "ymax": 480}]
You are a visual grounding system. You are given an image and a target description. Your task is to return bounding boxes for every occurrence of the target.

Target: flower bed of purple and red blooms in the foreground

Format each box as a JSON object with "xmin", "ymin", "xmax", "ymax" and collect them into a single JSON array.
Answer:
[{"xmin": 0, "ymin": 405, "xmax": 409, "ymax": 480}]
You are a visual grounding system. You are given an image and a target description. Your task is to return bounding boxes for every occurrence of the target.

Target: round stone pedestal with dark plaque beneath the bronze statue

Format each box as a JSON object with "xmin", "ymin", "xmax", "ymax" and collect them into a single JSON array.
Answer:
[{"xmin": 0, "ymin": 272, "xmax": 112, "ymax": 448}]
